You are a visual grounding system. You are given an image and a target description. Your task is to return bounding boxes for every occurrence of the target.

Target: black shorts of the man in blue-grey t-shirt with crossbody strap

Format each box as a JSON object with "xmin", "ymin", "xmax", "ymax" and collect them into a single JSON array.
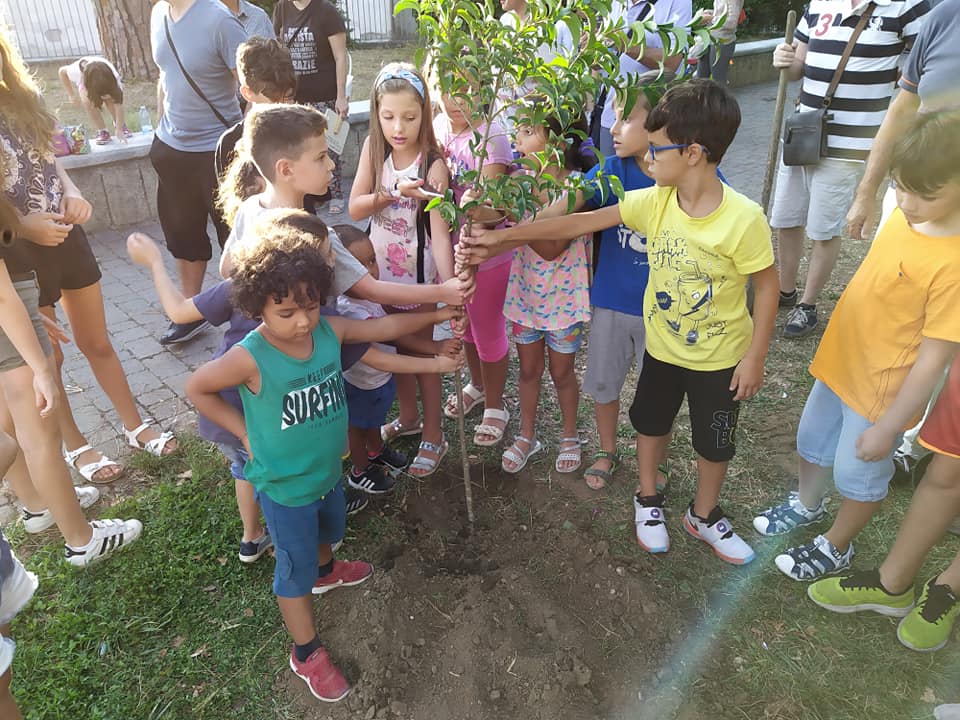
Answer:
[{"xmin": 150, "ymin": 137, "xmax": 230, "ymax": 261}]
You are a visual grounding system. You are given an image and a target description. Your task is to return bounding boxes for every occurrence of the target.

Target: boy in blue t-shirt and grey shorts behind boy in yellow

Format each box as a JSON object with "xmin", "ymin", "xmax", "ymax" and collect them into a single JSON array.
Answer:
[{"xmin": 461, "ymin": 71, "xmax": 673, "ymax": 490}]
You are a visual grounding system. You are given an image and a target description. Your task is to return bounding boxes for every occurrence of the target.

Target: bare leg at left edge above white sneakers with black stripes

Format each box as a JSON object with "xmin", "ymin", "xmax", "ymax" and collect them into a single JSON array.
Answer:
[{"xmin": 0, "ymin": 366, "xmax": 93, "ymax": 547}]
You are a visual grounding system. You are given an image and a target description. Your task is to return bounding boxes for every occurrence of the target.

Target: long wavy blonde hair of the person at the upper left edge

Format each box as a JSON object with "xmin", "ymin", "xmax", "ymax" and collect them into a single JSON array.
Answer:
[{"xmin": 0, "ymin": 27, "xmax": 56, "ymax": 152}]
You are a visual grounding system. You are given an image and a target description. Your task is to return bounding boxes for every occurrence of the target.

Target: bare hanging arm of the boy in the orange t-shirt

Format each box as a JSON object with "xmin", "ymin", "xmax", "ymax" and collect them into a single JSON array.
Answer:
[{"xmin": 857, "ymin": 337, "xmax": 960, "ymax": 462}]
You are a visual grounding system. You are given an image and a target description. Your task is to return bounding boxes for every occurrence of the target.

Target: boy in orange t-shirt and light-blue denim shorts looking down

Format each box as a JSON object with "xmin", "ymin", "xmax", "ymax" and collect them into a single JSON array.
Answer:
[{"xmin": 753, "ymin": 112, "xmax": 960, "ymax": 580}]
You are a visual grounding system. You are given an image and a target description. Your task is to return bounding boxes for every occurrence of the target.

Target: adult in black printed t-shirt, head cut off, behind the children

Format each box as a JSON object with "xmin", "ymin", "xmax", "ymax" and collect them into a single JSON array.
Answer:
[{"xmin": 273, "ymin": 0, "xmax": 349, "ymax": 215}]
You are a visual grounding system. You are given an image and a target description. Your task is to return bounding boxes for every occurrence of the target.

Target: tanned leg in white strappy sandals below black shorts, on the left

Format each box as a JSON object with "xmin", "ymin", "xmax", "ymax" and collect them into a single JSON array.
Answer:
[{"xmin": 55, "ymin": 282, "xmax": 177, "ymax": 455}]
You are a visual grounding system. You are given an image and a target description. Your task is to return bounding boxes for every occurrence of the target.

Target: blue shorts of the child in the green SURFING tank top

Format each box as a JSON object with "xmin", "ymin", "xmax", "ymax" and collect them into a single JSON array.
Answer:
[{"xmin": 257, "ymin": 482, "xmax": 347, "ymax": 598}]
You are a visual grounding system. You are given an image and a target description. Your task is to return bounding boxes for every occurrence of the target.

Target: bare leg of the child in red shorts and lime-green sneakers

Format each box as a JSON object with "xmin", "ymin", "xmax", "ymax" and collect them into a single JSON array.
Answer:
[{"xmin": 880, "ymin": 454, "xmax": 960, "ymax": 594}]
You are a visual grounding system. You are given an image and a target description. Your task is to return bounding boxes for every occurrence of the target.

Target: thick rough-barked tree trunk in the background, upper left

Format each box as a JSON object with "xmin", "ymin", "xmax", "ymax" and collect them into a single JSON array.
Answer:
[{"xmin": 94, "ymin": 0, "xmax": 158, "ymax": 80}]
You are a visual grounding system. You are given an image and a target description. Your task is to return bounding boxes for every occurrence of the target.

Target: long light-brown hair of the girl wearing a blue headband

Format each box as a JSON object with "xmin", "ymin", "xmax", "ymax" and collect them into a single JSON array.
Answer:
[{"xmin": 370, "ymin": 63, "xmax": 440, "ymax": 193}]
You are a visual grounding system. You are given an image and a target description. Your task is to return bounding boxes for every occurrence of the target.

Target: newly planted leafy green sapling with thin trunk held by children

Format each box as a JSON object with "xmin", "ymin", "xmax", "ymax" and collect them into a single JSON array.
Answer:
[{"xmin": 395, "ymin": 0, "xmax": 723, "ymax": 523}]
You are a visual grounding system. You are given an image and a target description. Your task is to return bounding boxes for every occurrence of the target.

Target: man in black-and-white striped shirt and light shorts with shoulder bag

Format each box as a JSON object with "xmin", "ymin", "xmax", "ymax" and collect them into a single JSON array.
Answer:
[{"xmin": 770, "ymin": 0, "xmax": 930, "ymax": 338}]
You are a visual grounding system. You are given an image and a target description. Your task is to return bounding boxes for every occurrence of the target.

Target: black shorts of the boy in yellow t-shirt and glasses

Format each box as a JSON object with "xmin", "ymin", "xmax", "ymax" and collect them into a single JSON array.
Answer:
[{"xmin": 630, "ymin": 353, "xmax": 740, "ymax": 462}]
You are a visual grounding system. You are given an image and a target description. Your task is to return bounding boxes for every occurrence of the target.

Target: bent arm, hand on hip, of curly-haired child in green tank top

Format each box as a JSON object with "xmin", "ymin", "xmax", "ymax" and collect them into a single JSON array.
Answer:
[{"xmin": 185, "ymin": 345, "xmax": 260, "ymax": 457}]
